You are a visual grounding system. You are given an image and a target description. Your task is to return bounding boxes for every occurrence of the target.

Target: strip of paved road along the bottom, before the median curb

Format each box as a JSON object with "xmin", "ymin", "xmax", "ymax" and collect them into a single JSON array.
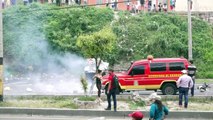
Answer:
[{"xmin": 0, "ymin": 115, "xmax": 211, "ymax": 120}]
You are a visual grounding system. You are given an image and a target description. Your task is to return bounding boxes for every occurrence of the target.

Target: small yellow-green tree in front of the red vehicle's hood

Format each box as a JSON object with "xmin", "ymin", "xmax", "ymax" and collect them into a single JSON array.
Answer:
[{"xmin": 77, "ymin": 27, "xmax": 116, "ymax": 70}]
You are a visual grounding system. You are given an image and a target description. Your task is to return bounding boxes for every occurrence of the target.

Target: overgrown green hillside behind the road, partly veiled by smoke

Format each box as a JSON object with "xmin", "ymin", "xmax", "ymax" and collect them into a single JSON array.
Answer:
[{"xmin": 4, "ymin": 4, "xmax": 213, "ymax": 78}]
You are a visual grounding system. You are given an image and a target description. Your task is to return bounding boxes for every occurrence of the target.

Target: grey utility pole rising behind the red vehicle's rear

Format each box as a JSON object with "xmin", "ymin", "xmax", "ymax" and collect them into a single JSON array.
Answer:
[{"xmin": 188, "ymin": 0, "xmax": 193, "ymax": 60}]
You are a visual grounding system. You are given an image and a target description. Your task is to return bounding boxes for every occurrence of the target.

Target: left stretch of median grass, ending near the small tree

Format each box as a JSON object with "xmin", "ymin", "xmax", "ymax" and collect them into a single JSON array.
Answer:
[{"xmin": 0, "ymin": 96, "xmax": 96, "ymax": 109}]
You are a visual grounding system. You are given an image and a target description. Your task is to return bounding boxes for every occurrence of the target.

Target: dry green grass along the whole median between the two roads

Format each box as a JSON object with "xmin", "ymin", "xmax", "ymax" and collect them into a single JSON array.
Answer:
[{"xmin": 0, "ymin": 96, "xmax": 213, "ymax": 111}]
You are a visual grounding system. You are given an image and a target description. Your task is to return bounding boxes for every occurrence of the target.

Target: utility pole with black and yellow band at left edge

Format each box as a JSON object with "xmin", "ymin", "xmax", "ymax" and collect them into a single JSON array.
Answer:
[{"xmin": 0, "ymin": 0, "xmax": 3, "ymax": 101}]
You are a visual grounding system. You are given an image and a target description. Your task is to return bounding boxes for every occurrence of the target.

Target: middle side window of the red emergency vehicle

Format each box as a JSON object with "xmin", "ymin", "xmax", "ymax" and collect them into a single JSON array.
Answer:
[{"xmin": 150, "ymin": 63, "xmax": 166, "ymax": 72}]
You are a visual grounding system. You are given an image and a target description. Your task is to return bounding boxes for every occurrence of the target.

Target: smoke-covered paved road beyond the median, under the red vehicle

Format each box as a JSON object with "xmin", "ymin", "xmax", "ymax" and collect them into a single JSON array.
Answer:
[{"xmin": 4, "ymin": 81, "xmax": 213, "ymax": 96}]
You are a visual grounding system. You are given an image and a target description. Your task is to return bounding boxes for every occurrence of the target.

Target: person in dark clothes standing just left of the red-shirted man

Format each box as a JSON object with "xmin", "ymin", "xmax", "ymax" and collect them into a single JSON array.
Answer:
[{"xmin": 93, "ymin": 70, "xmax": 102, "ymax": 101}]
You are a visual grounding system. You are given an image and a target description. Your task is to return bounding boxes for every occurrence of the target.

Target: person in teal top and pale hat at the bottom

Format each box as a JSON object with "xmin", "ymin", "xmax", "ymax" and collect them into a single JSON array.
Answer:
[{"xmin": 149, "ymin": 93, "xmax": 169, "ymax": 120}]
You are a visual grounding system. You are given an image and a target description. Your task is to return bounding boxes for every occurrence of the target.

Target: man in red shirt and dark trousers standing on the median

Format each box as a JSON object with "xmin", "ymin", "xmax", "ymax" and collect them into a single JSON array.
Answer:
[{"xmin": 105, "ymin": 69, "xmax": 117, "ymax": 112}]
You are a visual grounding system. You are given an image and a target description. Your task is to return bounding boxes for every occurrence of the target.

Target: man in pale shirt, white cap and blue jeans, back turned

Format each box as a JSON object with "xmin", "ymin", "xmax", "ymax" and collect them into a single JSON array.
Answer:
[{"xmin": 176, "ymin": 70, "xmax": 194, "ymax": 108}]
